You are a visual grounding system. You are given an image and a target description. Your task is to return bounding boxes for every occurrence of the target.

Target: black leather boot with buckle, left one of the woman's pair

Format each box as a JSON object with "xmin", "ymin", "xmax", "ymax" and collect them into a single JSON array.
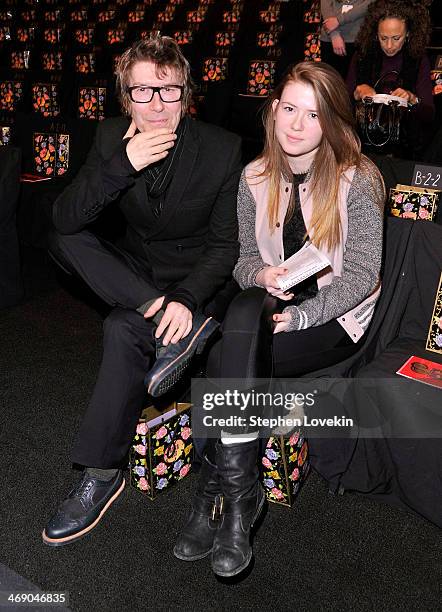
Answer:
[{"xmin": 173, "ymin": 457, "xmax": 222, "ymax": 561}]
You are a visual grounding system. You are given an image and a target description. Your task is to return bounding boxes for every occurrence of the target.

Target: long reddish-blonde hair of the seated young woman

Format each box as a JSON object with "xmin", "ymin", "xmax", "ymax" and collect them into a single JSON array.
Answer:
[{"xmin": 259, "ymin": 62, "xmax": 370, "ymax": 248}]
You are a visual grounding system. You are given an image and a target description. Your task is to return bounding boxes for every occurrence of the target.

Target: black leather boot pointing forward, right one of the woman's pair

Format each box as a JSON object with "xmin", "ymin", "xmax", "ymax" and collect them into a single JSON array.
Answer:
[{"xmin": 212, "ymin": 440, "xmax": 265, "ymax": 578}]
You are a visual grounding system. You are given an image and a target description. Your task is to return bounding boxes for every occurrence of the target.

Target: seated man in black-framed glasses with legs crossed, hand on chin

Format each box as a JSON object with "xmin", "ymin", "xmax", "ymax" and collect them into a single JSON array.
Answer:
[{"xmin": 43, "ymin": 35, "xmax": 241, "ymax": 546}]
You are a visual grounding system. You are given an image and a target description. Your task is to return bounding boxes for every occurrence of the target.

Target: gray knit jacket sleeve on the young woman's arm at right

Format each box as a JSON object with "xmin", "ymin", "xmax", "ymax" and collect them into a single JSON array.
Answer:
[{"xmin": 284, "ymin": 162, "xmax": 384, "ymax": 331}]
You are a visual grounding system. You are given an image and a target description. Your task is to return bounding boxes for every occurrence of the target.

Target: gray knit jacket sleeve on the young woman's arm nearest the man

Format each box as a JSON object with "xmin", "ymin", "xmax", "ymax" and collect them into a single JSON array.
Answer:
[{"xmin": 233, "ymin": 170, "xmax": 267, "ymax": 289}]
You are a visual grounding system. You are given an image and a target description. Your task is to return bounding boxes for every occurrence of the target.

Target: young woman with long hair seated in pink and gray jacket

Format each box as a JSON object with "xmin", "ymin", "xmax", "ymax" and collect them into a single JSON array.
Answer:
[{"xmin": 174, "ymin": 62, "xmax": 385, "ymax": 577}]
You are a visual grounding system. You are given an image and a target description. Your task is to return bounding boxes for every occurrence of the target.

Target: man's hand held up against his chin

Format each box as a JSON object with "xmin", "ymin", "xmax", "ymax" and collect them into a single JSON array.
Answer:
[{"xmin": 124, "ymin": 120, "xmax": 177, "ymax": 171}]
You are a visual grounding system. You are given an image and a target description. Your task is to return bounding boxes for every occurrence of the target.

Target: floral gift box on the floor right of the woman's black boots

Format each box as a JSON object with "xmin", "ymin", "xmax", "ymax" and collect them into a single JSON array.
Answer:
[{"xmin": 262, "ymin": 431, "xmax": 310, "ymax": 506}]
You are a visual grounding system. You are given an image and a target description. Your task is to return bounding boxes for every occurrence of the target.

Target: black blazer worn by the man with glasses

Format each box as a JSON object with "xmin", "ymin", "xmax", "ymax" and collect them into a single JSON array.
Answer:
[{"xmin": 53, "ymin": 117, "xmax": 245, "ymax": 306}]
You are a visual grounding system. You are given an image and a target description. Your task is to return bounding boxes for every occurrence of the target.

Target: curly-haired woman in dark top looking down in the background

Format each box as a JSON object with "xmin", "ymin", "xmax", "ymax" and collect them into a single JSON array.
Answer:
[{"xmin": 347, "ymin": 0, "xmax": 435, "ymax": 155}]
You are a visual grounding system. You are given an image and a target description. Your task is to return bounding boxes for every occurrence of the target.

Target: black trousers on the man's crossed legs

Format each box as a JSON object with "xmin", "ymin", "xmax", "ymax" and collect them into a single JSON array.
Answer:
[{"xmin": 50, "ymin": 231, "xmax": 162, "ymax": 468}]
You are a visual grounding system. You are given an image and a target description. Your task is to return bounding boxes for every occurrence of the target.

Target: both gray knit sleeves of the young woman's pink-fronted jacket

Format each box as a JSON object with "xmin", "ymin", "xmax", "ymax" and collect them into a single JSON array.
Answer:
[{"xmin": 233, "ymin": 166, "xmax": 384, "ymax": 331}]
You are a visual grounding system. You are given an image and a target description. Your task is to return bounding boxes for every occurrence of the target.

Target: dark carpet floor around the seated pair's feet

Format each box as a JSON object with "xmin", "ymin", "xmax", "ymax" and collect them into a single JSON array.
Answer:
[{"xmin": 0, "ymin": 250, "xmax": 442, "ymax": 612}]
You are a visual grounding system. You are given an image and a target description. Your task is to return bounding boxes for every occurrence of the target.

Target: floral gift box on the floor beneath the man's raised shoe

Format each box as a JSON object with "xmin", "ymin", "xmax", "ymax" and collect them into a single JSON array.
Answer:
[{"xmin": 129, "ymin": 402, "xmax": 193, "ymax": 500}]
